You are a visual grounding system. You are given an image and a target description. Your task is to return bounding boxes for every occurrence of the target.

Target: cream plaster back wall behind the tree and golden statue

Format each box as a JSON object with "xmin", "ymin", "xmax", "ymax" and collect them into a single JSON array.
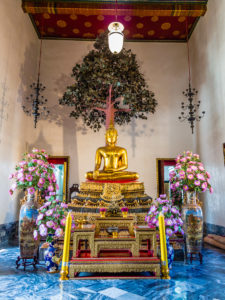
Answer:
[{"xmin": 27, "ymin": 40, "xmax": 194, "ymax": 197}]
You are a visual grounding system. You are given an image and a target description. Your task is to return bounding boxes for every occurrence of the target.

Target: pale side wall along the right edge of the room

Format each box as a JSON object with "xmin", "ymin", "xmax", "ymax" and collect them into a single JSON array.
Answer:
[{"xmin": 190, "ymin": 0, "xmax": 225, "ymax": 226}]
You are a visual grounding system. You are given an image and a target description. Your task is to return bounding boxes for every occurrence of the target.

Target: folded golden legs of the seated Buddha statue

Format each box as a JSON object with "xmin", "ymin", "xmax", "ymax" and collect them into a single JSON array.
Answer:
[{"xmin": 85, "ymin": 171, "xmax": 139, "ymax": 180}]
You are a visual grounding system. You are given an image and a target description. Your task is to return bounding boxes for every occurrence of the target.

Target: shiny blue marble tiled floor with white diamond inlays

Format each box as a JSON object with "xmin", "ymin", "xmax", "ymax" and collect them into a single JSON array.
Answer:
[{"xmin": 0, "ymin": 247, "xmax": 225, "ymax": 300}]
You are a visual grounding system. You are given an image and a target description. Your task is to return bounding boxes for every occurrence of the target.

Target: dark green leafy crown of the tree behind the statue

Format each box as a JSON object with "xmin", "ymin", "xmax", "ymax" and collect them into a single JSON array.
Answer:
[{"xmin": 59, "ymin": 33, "xmax": 157, "ymax": 131}]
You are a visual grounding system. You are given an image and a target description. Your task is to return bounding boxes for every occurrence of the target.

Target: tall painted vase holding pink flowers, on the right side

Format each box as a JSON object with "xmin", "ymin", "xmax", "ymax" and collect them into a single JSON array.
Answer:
[{"xmin": 182, "ymin": 191, "xmax": 203, "ymax": 254}]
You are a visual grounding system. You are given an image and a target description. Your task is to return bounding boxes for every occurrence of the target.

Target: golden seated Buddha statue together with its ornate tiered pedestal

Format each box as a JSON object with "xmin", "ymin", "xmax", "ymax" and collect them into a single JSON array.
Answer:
[{"xmin": 69, "ymin": 124, "xmax": 152, "ymax": 224}]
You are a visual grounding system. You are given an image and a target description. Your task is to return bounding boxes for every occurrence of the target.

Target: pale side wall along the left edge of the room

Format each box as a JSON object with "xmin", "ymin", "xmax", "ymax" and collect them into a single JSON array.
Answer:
[{"xmin": 0, "ymin": 0, "xmax": 38, "ymax": 224}]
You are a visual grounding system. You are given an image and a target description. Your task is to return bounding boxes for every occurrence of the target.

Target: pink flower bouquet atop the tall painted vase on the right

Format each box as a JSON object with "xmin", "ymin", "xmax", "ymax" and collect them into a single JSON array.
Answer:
[{"xmin": 170, "ymin": 151, "xmax": 213, "ymax": 193}]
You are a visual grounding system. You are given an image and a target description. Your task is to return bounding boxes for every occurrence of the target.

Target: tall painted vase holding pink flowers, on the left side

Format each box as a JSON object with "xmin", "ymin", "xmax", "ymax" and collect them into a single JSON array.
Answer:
[{"xmin": 19, "ymin": 194, "xmax": 39, "ymax": 259}]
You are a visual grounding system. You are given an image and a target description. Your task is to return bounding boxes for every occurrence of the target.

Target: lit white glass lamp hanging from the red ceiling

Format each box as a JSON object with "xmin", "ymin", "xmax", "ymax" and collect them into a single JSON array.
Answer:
[{"xmin": 108, "ymin": 22, "xmax": 124, "ymax": 54}]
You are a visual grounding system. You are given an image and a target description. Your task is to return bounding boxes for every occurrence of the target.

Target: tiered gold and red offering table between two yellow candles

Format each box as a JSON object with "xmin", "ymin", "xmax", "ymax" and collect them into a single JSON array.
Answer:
[{"xmin": 69, "ymin": 217, "xmax": 160, "ymax": 278}]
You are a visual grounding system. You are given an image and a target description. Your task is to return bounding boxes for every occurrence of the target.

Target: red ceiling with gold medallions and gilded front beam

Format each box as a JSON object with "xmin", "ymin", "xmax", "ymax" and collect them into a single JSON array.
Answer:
[{"xmin": 22, "ymin": 0, "xmax": 207, "ymax": 42}]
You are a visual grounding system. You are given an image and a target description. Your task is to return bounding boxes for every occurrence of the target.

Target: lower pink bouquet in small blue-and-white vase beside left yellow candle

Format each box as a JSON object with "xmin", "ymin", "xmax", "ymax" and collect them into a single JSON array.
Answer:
[{"xmin": 33, "ymin": 196, "xmax": 75, "ymax": 243}]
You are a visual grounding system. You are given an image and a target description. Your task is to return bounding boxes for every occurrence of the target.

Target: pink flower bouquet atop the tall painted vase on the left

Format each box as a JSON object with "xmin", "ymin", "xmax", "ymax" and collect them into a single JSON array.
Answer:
[{"xmin": 9, "ymin": 149, "xmax": 57, "ymax": 197}]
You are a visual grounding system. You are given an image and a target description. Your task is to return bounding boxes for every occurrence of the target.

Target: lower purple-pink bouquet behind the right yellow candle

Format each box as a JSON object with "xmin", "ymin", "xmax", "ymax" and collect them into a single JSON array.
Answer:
[{"xmin": 145, "ymin": 195, "xmax": 184, "ymax": 236}]
